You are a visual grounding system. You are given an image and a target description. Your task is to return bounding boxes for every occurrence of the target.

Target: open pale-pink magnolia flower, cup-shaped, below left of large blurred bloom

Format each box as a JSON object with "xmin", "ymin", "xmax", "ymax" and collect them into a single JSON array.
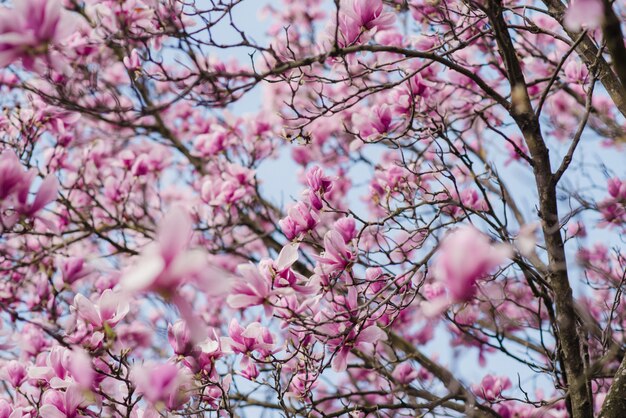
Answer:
[{"xmin": 74, "ymin": 289, "xmax": 130, "ymax": 328}]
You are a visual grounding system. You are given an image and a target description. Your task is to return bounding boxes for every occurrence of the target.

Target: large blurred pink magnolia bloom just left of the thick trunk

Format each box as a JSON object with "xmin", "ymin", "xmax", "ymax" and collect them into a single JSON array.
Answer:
[{"xmin": 423, "ymin": 226, "xmax": 510, "ymax": 315}]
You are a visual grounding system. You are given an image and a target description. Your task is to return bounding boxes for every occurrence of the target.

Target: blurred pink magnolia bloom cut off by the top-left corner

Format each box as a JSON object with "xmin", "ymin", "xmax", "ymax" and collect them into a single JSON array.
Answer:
[{"xmin": 0, "ymin": 0, "xmax": 77, "ymax": 68}]
